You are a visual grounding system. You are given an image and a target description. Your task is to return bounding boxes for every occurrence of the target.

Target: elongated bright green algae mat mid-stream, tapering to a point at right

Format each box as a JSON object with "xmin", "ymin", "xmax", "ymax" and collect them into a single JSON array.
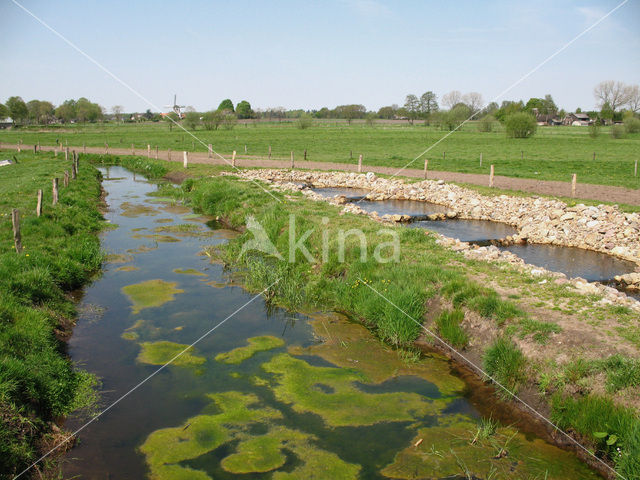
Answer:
[{"xmin": 262, "ymin": 353, "xmax": 449, "ymax": 427}]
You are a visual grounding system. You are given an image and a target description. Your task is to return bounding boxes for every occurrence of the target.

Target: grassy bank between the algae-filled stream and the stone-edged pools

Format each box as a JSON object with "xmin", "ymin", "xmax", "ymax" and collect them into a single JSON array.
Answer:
[{"xmin": 146, "ymin": 171, "xmax": 640, "ymax": 478}]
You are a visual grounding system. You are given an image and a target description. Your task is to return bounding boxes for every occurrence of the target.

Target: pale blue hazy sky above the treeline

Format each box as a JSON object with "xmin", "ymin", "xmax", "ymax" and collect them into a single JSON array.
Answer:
[{"xmin": 0, "ymin": 0, "xmax": 640, "ymax": 112}]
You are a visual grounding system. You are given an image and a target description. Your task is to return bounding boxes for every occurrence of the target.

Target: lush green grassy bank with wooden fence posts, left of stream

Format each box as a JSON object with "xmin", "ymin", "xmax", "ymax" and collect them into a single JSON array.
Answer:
[{"xmin": 0, "ymin": 152, "xmax": 103, "ymax": 478}]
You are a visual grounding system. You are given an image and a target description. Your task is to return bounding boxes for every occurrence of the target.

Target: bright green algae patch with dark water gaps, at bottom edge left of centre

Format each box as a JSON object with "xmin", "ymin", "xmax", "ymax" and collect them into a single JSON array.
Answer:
[{"xmin": 140, "ymin": 392, "xmax": 360, "ymax": 480}]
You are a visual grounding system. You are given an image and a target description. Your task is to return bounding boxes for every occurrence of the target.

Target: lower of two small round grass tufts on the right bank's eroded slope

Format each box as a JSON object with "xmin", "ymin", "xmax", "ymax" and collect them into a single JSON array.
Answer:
[{"xmin": 482, "ymin": 337, "xmax": 525, "ymax": 396}]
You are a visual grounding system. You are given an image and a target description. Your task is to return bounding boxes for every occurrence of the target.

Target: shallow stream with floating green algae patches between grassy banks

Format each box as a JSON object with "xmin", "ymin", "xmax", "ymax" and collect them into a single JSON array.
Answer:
[{"xmin": 64, "ymin": 167, "xmax": 600, "ymax": 480}]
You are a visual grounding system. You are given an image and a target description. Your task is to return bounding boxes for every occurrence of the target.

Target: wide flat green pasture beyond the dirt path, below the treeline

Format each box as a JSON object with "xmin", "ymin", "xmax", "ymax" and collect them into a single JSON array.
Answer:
[{"xmin": 0, "ymin": 121, "xmax": 640, "ymax": 189}]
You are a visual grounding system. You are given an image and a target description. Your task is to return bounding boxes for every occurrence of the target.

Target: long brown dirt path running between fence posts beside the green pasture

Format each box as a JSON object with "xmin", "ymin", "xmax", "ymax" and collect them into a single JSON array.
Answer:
[{"xmin": 15, "ymin": 145, "xmax": 640, "ymax": 206}]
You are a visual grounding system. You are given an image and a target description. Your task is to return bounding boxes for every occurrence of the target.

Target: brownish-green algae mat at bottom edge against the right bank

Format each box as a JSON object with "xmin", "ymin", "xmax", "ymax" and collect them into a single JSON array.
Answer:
[{"xmin": 381, "ymin": 415, "xmax": 600, "ymax": 480}]
